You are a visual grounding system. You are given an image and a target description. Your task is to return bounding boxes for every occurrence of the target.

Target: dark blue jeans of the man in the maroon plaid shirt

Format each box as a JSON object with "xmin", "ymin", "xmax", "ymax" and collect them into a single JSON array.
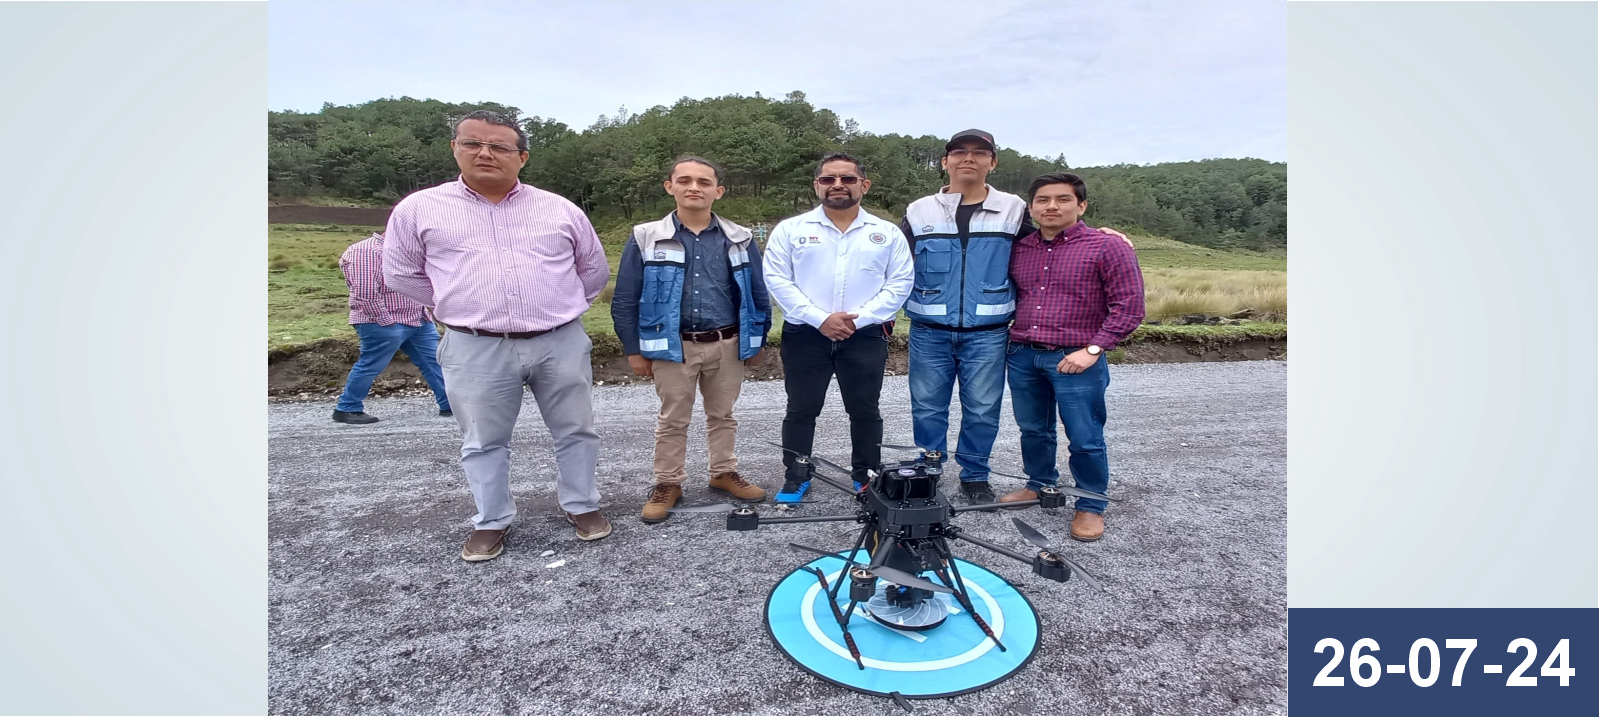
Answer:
[{"xmin": 1006, "ymin": 344, "xmax": 1110, "ymax": 512}]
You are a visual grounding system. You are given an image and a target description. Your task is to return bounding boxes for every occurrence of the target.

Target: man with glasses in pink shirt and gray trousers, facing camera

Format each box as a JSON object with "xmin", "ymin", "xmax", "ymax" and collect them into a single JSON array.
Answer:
[{"xmin": 384, "ymin": 110, "xmax": 611, "ymax": 560}]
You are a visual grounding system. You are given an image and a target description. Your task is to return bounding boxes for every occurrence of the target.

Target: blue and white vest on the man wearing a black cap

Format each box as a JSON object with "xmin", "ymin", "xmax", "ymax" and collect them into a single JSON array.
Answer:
[{"xmin": 905, "ymin": 187, "xmax": 1027, "ymax": 328}]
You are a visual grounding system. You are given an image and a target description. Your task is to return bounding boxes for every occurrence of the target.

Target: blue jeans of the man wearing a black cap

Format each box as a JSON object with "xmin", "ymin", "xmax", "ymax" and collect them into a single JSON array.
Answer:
[{"xmin": 910, "ymin": 323, "xmax": 1011, "ymax": 482}]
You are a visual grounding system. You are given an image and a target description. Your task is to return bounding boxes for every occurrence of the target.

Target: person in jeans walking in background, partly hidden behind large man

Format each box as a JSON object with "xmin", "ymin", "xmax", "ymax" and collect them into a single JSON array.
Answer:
[{"xmin": 333, "ymin": 232, "xmax": 451, "ymax": 426}]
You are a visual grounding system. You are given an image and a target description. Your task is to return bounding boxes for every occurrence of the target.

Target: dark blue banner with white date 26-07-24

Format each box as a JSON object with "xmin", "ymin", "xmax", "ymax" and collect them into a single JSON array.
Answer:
[{"xmin": 1289, "ymin": 608, "xmax": 1599, "ymax": 717}]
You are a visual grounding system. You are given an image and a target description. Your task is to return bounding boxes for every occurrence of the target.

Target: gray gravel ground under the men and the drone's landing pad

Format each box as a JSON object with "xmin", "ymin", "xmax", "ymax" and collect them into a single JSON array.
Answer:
[{"xmin": 267, "ymin": 362, "xmax": 1287, "ymax": 714}]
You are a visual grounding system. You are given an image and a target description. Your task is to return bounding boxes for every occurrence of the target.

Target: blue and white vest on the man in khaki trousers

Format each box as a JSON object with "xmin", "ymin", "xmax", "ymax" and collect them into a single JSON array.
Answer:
[{"xmin": 633, "ymin": 214, "xmax": 766, "ymax": 363}]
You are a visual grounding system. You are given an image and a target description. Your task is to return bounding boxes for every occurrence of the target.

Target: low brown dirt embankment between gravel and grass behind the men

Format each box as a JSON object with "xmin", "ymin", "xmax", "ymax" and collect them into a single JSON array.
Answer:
[{"xmin": 267, "ymin": 336, "xmax": 1289, "ymax": 399}]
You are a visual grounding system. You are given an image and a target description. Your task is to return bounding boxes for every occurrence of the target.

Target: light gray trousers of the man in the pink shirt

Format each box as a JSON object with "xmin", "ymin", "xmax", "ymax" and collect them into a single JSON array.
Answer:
[{"xmin": 438, "ymin": 322, "xmax": 600, "ymax": 530}]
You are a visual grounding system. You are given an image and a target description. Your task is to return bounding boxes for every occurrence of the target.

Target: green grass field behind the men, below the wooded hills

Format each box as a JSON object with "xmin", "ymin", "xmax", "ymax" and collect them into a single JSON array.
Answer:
[{"xmin": 267, "ymin": 221, "xmax": 1287, "ymax": 347}]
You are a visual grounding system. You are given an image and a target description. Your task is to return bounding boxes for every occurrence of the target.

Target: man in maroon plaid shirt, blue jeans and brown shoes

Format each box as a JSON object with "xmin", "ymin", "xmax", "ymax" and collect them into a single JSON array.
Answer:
[{"xmin": 999, "ymin": 174, "xmax": 1143, "ymax": 541}]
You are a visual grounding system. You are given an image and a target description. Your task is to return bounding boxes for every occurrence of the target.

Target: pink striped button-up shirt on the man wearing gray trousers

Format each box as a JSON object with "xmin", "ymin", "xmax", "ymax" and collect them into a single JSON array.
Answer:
[{"xmin": 384, "ymin": 178, "xmax": 611, "ymax": 331}]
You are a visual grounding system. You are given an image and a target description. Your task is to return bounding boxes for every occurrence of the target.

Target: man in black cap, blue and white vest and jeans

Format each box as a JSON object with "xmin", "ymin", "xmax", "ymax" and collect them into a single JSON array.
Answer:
[{"xmin": 900, "ymin": 130, "xmax": 1033, "ymax": 504}]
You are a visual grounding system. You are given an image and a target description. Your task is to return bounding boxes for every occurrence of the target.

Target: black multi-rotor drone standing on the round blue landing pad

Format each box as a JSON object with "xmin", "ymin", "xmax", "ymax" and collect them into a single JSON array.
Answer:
[{"xmin": 672, "ymin": 443, "xmax": 1110, "ymax": 704}]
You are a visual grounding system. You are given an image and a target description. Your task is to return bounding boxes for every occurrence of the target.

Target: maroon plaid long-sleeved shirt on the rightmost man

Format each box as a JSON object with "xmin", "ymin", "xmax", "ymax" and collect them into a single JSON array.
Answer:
[{"xmin": 1011, "ymin": 221, "xmax": 1143, "ymax": 350}]
